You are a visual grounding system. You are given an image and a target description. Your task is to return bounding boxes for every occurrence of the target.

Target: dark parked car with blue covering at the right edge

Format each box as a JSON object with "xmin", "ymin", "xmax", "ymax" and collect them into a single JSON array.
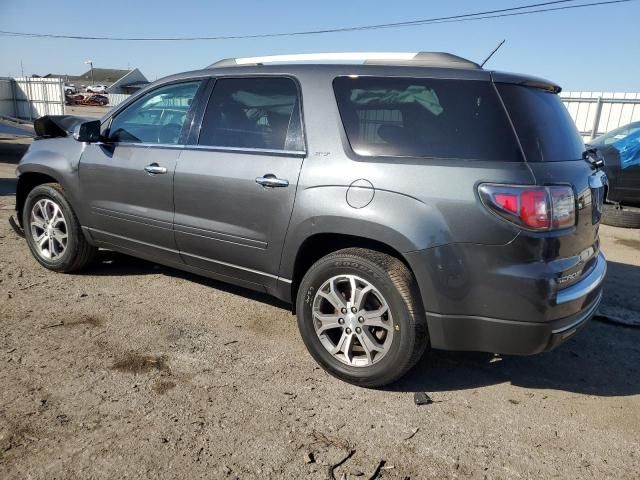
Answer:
[{"xmin": 589, "ymin": 121, "xmax": 640, "ymax": 228}]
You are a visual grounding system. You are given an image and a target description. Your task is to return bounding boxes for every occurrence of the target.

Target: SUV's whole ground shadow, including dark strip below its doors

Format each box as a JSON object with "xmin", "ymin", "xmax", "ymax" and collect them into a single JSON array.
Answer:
[{"xmin": 82, "ymin": 250, "xmax": 640, "ymax": 396}]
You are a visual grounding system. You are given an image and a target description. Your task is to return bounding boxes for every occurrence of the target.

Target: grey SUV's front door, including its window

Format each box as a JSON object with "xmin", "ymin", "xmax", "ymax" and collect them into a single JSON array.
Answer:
[{"xmin": 79, "ymin": 81, "xmax": 201, "ymax": 263}]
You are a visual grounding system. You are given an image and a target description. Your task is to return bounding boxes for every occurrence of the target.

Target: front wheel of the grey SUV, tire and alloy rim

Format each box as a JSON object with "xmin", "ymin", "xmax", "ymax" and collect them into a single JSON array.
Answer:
[{"xmin": 22, "ymin": 183, "xmax": 98, "ymax": 273}]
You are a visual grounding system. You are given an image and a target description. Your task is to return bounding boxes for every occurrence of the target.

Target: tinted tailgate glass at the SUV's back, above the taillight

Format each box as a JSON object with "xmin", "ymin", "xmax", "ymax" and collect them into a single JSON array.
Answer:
[{"xmin": 498, "ymin": 83, "xmax": 584, "ymax": 162}]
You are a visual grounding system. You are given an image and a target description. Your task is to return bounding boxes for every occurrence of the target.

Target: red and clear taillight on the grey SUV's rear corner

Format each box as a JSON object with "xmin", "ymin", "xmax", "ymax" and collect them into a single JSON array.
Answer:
[{"xmin": 478, "ymin": 183, "xmax": 576, "ymax": 231}]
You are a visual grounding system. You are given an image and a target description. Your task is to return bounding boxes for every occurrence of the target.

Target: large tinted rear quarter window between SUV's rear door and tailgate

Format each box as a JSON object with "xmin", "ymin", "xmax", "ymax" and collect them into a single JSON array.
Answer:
[{"xmin": 333, "ymin": 77, "xmax": 521, "ymax": 161}]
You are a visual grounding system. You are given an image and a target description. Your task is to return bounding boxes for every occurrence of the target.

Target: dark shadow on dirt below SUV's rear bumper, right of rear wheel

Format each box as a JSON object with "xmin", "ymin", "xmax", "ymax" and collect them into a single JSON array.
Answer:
[{"xmin": 387, "ymin": 262, "xmax": 640, "ymax": 396}]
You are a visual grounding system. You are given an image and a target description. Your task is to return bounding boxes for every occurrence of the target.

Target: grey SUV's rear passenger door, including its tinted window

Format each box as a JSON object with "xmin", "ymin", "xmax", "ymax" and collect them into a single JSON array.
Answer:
[{"xmin": 174, "ymin": 77, "xmax": 305, "ymax": 286}]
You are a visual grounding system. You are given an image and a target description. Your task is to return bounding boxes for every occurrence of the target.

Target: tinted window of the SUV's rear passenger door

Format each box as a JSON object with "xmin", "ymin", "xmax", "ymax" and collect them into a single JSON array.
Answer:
[{"xmin": 198, "ymin": 78, "xmax": 304, "ymax": 151}]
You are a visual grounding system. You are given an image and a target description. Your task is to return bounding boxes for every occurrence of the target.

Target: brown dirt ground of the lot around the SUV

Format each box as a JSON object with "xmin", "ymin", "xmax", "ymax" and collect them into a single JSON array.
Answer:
[{"xmin": 0, "ymin": 137, "xmax": 640, "ymax": 479}]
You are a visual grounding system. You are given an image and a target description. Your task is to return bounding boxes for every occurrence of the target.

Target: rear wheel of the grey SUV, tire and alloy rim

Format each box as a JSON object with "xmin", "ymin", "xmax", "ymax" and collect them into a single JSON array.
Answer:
[{"xmin": 296, "ymin": 248, "xmax": 429, "ymax": 387}]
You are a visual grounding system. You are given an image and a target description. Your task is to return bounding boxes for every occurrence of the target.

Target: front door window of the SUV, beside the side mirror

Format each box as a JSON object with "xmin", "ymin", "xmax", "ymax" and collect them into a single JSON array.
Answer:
[{"xmin": 109, "ymin": 81, "xmax": 200, "ymax": 145}]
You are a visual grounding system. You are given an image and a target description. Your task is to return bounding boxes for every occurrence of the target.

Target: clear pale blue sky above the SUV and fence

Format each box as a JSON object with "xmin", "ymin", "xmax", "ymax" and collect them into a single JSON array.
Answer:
[{"xmin": 0, "ymin": 0, "xmax": 640, "ymax": 92}]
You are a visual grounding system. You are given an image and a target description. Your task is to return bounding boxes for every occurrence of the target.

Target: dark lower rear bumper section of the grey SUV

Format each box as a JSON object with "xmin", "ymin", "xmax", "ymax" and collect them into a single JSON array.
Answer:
[{"xmin": 427, "ymin": 290, "xmax": 602, "ymax": 355}]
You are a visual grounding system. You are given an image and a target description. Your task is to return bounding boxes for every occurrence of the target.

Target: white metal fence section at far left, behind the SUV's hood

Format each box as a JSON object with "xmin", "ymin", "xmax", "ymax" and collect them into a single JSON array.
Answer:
[{"xmin": 0, "ymin": 78, "xmax": 64, "ymax": 120}]
